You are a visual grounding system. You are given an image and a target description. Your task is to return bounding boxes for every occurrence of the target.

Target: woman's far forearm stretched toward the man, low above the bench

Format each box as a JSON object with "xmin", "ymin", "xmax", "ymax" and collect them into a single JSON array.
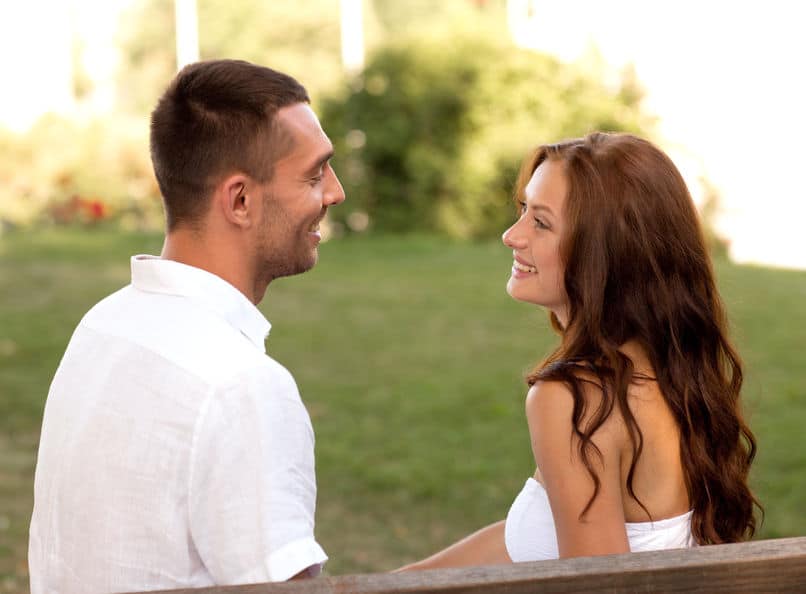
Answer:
[{"xmin": 397, "ymin": 520, "xmax": 512, "ymax": 571}]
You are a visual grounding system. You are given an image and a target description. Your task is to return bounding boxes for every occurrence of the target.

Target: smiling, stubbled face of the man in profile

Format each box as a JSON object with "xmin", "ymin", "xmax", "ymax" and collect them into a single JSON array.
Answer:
[{"xmin": 256, "ymin": 103, "xmax": 344, "ymax": 282}]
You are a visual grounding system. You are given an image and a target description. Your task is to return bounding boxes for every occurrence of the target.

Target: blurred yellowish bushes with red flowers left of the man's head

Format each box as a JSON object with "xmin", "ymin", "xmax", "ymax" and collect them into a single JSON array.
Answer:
[{"xmin": 0, "ymin": 115, "xmax": 162, "ymax": 229}]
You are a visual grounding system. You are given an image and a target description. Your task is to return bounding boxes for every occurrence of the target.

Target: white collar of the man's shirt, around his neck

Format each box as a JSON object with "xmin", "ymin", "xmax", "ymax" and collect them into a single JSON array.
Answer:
[{"xmin": 131, "ymin": 255, "xmax": 271, "ymax": 353}]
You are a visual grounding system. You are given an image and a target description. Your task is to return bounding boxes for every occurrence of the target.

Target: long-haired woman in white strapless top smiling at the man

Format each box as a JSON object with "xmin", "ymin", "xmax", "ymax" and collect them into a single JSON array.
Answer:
[{"xmin": 404, "ymin": 133, "xmax": 758, "ymax": 569}]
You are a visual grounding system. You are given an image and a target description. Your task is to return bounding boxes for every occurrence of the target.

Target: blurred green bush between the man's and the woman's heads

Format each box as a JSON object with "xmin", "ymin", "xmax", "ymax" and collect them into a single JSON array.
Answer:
[{"xmin": 322, "ymin": 33, "xmax": 651, "ymax": 238}]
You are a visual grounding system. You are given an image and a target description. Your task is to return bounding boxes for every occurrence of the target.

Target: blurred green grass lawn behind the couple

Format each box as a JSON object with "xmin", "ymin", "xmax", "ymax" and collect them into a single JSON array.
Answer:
[{"xmin": 0, "ymin": 230, "xmax": 806, "ymax": 592}]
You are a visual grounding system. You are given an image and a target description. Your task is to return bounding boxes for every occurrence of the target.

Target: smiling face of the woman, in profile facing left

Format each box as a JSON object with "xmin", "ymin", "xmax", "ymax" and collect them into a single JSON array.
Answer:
[{"xmin": 503, "ymin": 160, "xmax": 568, "ymax": 326}]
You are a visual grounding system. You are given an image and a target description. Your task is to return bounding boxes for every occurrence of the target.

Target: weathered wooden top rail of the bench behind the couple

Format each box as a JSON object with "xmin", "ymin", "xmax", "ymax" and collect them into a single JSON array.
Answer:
[{"xmin": 131, "ymin": 537, "xmax": 806, "ymax": 594}]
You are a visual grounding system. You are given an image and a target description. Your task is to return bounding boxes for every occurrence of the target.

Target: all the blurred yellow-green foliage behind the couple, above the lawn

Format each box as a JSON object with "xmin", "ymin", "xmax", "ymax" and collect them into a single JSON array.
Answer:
[{"xmin": 0, "ymin": 0, "xmax": 650, "ymax": 238}]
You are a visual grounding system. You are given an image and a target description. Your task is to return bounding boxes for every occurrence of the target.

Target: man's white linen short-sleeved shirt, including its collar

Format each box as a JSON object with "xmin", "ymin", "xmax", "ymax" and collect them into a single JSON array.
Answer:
[{"xmin": 28, "ymin": 256, "xmax": 327, "ymax": 594}]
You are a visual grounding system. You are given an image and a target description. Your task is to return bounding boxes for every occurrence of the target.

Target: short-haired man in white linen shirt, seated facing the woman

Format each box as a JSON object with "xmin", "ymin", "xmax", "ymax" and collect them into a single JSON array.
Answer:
[{"xmin": 29, "ymin": 60, "xmax": 344, "ymax": 594}]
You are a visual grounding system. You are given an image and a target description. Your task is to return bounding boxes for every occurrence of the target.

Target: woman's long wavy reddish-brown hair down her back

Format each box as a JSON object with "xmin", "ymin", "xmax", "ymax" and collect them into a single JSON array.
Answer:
[{"xmin": 517, "ymin": 133, "xmax": 760, "ymax": 544}]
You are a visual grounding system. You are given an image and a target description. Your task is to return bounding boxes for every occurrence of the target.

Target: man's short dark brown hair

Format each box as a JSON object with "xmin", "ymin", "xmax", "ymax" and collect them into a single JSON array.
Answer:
[{"xmin": 151, "ymin": 60, "xmax": 310, "ymax": 230}]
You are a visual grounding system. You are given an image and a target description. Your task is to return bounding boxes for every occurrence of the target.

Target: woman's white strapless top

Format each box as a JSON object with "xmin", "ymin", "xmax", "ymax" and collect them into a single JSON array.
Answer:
[{"xmin": 505, "ymin": 478, "xmax": 696, "ymax": 563}]
